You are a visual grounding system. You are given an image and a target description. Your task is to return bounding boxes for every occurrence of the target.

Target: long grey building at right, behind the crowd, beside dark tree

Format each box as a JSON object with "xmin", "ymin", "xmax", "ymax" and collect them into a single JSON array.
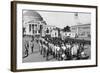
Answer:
[{"xmin": 71, "ymin": 24, "xmax": 91, "ymax": 38}]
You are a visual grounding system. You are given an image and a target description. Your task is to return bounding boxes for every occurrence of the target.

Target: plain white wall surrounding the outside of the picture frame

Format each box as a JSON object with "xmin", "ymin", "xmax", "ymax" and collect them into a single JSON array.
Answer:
[{"xmin": 0, "ymin": 0, "xmax": 100, "ymax": 73}]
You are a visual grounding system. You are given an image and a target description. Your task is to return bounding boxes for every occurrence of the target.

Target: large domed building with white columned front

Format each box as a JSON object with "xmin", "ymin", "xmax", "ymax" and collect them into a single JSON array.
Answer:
[{"xmin": 23, "ymin": 10, "xmax": 46, "ymax": 36}]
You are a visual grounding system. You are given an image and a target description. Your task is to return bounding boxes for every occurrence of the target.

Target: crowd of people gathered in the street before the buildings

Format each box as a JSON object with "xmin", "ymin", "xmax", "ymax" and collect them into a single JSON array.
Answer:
[{"xmin": 24, "ymin": 37, "xmax": 90, "ymax": 61}]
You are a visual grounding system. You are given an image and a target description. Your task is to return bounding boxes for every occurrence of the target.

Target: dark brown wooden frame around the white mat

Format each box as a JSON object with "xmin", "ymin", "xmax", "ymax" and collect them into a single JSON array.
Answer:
[{"xmin": 11, "ymin": 1, "xmax": 98, "ymax": 72}]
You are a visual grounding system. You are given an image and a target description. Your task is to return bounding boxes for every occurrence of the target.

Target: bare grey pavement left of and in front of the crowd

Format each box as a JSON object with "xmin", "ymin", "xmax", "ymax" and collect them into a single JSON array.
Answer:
[{"xmin": 23, "ymin": 37, "xmax": 55, "ymax": 63}]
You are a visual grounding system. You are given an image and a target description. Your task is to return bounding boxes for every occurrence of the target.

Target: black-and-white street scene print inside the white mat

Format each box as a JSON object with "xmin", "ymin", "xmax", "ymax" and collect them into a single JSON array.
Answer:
[{"xmin": 22, "ymin": 10, "xmax": 91, "ymax": 63}]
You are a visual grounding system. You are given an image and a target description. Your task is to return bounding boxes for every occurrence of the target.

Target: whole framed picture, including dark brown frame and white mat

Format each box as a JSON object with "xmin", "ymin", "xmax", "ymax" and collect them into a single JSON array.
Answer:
[{"xmin": 11, "ymin": 2, "xmax": 97, "ymax": 71}]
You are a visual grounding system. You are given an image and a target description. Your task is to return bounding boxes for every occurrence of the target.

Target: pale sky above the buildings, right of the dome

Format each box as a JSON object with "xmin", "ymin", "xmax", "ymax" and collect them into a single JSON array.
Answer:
[{"xmin": 37, "ymin": 11, "xmax": 91, "ymax": 28}]
